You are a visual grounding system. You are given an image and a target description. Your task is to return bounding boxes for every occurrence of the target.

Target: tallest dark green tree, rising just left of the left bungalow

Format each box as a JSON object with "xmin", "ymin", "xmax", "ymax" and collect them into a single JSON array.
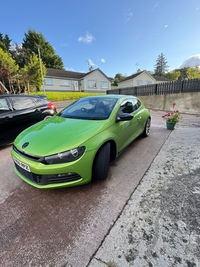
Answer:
[{"xmin": 22, "ymin": 29, "xmax": 64, "ymax": 69}]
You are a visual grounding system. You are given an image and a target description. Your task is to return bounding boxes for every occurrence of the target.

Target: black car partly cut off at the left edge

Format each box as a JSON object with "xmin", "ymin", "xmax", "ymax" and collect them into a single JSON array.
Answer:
[{"xmin": 0, "ymin": 95, "xmax": 57, "ymax": 146}]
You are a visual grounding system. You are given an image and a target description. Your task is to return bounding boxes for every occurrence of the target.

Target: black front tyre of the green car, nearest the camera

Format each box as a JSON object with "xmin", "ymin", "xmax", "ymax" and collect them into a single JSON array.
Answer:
[{"xmin": 92, "ymin": 143, "xmax": 110, "ymax": 180}]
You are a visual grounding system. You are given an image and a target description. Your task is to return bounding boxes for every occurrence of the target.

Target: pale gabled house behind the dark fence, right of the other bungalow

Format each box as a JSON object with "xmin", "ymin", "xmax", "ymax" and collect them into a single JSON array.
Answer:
[{"xmin": 118, "ymin": 70, "xmax": 169, "ymax": 88}]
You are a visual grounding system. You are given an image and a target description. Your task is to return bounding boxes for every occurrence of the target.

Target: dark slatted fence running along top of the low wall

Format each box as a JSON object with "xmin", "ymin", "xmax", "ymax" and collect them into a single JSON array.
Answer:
[{"xmin": 106, "ymin": 79, "xmax": 200, "ymax": 96}]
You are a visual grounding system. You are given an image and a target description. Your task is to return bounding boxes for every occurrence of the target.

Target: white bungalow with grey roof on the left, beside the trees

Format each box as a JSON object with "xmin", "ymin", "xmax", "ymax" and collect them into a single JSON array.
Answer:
[{"xmin": 43, "ymin": 68, "xmax": 111, "ymax": 92}]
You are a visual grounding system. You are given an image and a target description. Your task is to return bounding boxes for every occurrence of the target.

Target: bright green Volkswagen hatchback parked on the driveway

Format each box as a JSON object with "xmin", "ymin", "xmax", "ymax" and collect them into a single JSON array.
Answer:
[{"xmin": 11, "ymin": 94, "xmax": 151, "ymax": 188}]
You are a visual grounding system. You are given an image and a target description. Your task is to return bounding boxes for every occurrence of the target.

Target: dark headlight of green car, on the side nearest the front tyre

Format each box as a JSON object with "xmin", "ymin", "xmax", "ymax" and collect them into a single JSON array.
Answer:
[{"xmin": 44, "ymin": 146, "xmax": 85, "ymax": 164}]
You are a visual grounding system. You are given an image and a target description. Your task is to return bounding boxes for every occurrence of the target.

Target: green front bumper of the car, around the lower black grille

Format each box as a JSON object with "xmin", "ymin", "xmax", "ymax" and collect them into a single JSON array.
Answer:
[{"xmin": 11, "ymin": 150, "xmax": 95, "ymax": 189}]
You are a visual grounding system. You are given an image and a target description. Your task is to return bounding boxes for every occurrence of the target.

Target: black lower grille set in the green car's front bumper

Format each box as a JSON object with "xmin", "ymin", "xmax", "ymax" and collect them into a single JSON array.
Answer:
[{"xmin": 15, "ymin": 164, "xmax": 81, "ymax": 185}]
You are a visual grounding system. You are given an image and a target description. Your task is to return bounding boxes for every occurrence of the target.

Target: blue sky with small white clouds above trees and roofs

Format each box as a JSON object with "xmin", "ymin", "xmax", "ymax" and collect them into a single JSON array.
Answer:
[{"xmin": 0, "ymin": 0, "xmax": 200, "ymax": 77}]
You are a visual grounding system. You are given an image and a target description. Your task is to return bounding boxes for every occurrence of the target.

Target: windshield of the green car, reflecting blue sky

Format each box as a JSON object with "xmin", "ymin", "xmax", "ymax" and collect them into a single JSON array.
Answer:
[{"xmin": 58, "ymin": 97, "xmax": 117, "ymax": 120}]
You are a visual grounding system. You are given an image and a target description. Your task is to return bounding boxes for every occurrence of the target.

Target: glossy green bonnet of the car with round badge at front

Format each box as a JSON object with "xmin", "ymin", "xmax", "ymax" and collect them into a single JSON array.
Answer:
[{"xmin": 14, "ymin": 116, "xmax": 107, "ymax": 156}]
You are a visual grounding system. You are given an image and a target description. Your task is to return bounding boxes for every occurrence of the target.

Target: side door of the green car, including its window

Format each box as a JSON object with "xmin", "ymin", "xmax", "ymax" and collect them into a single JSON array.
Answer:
[{"xmin": 115, "ymin": 99, "xmax": 140, "ymax": 152}]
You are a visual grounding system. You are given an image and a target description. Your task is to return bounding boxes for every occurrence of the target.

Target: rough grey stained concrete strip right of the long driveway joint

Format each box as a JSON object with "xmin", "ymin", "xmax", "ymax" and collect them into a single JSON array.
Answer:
[{"xmin": 88, "ymin": 115, "xmax": 200, "ymax": 267}]
